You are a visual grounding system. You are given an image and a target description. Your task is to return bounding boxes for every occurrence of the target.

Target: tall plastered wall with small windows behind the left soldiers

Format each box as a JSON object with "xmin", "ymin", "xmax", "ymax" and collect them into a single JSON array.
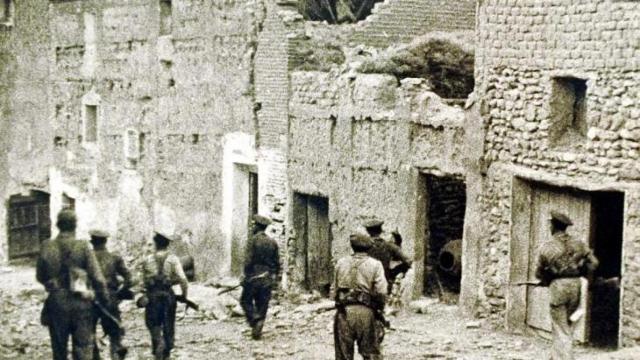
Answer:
[{"xmin": 49, "ymin": 0, "xmax": 262, "ymax": 276}]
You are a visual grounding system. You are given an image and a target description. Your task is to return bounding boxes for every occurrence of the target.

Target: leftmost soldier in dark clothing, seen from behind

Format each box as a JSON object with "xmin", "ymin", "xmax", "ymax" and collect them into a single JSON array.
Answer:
[{"xmin": 36, "ymin": 209, "xmax": 111, "ymax": 360}]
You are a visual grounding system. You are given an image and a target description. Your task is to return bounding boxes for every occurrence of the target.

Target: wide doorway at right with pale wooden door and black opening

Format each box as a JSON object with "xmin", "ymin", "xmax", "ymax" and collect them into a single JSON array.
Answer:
[{"xmin": 507, "ymin": 179, "xmax": 624, "ymax": 346}]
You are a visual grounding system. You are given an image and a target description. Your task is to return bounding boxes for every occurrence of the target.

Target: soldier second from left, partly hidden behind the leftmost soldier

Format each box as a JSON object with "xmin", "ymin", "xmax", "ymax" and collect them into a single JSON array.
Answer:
[{"xmin": 89, "ymin": 230, "xmax": 132, "ymax": 360}]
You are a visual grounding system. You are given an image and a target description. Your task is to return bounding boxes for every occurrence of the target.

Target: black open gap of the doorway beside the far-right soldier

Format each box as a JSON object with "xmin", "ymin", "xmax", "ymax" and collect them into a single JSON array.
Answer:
[{"xmin": 589, "ymin": 192, "xmax": 624, "ymax": 347}]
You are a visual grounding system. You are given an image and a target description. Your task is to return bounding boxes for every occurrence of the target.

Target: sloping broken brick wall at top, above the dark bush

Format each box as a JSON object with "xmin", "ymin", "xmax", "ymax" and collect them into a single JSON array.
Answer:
[{"xmin": 351, "ymin": 0, "xmax": 476, "ymax": 47}]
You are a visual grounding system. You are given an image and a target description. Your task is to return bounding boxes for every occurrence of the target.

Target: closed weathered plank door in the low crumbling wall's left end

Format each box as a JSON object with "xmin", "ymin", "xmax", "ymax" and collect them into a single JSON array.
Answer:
[{"xmin": 293, "ymin": 193, "xmax": 333, "ymax": 296}]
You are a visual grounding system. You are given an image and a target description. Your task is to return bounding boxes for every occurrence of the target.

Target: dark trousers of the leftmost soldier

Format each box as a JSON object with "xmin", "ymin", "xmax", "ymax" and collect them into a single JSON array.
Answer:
[{"xmin": 43, "ymin": 290, "xmax": 96, "ymax": 360}]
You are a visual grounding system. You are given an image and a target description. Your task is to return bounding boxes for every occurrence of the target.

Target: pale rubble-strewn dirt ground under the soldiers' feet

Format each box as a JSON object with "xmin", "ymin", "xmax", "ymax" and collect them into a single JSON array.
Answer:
[{"xmin": 0, "ymin": 268, "xmax": 640, "ymax": 360}]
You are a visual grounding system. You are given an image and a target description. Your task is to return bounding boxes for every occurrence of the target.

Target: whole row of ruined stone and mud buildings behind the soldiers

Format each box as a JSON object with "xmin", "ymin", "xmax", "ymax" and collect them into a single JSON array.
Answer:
[{"xmin": 0, "ymin": 0, "xmax": 640, "ymax": 352}]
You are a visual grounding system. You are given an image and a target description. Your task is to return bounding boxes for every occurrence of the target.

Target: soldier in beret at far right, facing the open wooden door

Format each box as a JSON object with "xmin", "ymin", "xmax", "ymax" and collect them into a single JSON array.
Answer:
[{"xmin": 536, "ymin": 211, "xmax": 598, "ymax": 360}]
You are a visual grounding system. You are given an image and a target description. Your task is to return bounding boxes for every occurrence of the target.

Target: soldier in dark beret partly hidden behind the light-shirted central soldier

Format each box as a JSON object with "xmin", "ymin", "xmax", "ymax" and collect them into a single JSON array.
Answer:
[{"xmin": 364, "ymin": 220, "xmax": 412, "ymax": 293}]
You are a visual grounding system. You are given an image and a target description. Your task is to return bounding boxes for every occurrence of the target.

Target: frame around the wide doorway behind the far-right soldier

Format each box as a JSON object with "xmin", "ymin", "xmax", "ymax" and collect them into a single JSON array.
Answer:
[{"xmin": 505, "ymin": 174, "xmax": 628, "ymax": 347}]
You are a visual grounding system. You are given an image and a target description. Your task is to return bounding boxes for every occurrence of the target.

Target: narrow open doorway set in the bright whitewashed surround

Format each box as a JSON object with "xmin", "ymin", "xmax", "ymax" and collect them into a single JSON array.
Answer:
[{"xmin": 231, "ymin": 164, "xmax": 258, "ymax": 275}]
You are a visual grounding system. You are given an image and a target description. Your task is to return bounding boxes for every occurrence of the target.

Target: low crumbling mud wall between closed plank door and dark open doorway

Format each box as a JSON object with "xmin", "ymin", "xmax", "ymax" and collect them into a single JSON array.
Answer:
[{"xmin": 288, "ymin": 71, "xmax": 464, "ymax": 294}]
